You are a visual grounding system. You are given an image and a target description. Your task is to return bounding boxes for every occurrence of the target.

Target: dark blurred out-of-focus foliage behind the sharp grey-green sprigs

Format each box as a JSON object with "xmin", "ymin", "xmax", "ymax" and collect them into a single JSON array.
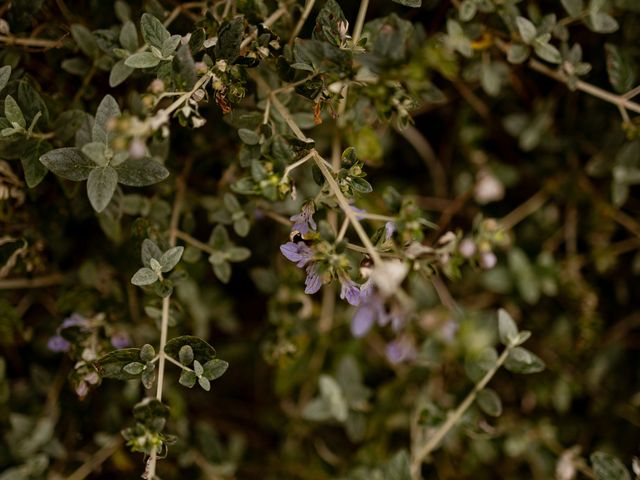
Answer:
[{"xmin": 0, "ymin": 0, "xmax": 640, "ymax": 480}]
